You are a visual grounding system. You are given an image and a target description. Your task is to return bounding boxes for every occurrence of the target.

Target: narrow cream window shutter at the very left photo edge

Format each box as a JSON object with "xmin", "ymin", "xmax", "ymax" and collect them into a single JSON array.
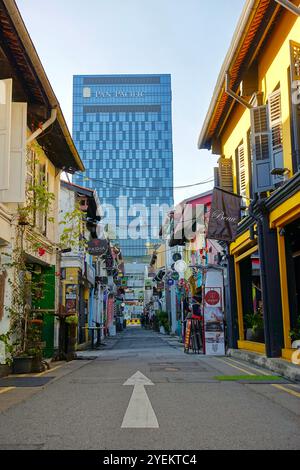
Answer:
[{"xmin": 0, "ymin": 79, "xmax": 12, "ymax": 190}]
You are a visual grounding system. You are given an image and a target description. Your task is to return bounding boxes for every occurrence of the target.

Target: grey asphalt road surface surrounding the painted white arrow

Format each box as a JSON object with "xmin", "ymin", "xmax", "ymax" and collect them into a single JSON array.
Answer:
[{"xmin": 0, "ymin": 328, "xmax": 300, "ymax": 450}]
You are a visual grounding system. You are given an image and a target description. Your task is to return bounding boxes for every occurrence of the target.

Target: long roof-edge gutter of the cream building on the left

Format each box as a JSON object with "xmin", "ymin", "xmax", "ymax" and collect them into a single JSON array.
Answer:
[{"xmin": 3, "ymin": 0, "xmax": 85, "ymax": 171}]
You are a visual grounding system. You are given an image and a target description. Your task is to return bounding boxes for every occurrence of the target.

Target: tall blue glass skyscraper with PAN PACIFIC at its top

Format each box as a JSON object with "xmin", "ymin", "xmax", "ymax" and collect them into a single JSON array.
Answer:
[{"xmin": 73, "ymin": 75, "xmax": 173, "ymax": 261}]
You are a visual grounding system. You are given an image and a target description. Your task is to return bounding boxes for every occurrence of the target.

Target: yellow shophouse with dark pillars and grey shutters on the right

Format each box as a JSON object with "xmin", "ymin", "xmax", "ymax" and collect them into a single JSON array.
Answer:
[{"xmin": 199, "ymin": 0, "xmax": 300, "ymax": 359}]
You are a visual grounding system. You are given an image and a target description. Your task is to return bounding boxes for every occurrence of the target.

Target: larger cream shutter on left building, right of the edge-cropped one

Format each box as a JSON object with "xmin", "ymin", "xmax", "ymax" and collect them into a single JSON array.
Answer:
[{"xmin": 0, "ymin": 103, "xmax": 27, "ymax": 202}]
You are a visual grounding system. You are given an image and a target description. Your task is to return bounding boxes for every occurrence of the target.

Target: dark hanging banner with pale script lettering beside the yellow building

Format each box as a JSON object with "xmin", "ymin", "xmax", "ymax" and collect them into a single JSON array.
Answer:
[{"xmin": 207, "ymin": 188, "xmax": 242, "ymax": 242}]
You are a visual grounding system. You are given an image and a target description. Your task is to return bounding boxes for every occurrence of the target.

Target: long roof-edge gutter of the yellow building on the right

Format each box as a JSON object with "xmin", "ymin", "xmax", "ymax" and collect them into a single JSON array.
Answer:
[{"xmin": 198, "ymin": 0, "xmax": 259, "ymax": 150}]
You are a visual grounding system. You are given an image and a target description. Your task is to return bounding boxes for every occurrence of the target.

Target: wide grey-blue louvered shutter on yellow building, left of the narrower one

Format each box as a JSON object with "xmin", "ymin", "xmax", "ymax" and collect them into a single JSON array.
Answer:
[{"xmin": 250, "ymin": 106, "xmax": 273, "ymax": 193}]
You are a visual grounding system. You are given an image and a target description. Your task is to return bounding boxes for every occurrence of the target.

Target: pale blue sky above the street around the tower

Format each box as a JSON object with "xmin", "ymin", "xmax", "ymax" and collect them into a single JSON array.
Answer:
[{"xmin": 17, "ymin": 0, "xmax": 244, "ymax": 202}]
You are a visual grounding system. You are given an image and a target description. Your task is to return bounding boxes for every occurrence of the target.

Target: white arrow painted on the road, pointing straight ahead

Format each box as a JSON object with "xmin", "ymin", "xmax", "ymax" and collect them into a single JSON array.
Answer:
[{"xmin": 122, "ymin": 372, "xmax": 159, "ymax": 429}]
